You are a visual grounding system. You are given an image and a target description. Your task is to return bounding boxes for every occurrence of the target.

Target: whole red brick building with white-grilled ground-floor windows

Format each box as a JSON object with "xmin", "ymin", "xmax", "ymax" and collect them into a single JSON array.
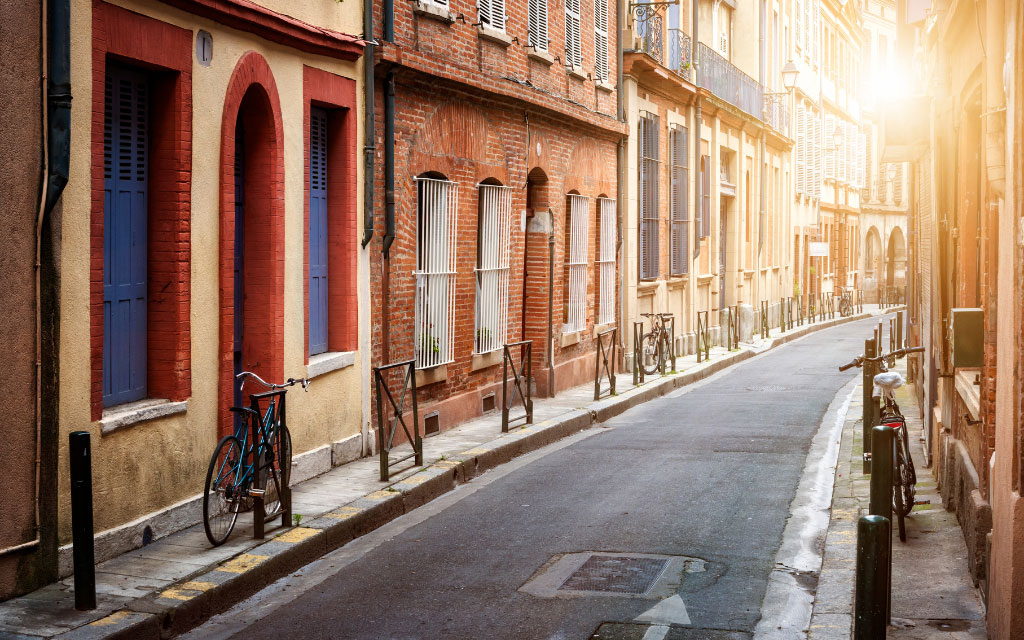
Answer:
[{"xmin": 371, "ymin": 0, "xmax": 626, "ymax": 434}]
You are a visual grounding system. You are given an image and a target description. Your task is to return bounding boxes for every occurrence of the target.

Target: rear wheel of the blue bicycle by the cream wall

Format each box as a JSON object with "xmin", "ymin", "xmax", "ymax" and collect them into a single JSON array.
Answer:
[{"xmin": 203, "ymin": 435, "xmax": 245, "ymax": 547}]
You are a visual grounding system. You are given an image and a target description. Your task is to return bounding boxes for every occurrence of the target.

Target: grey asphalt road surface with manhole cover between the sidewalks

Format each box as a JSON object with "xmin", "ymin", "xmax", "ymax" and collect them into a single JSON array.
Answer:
[{"xmin": 188, "ymin": 321, "xmax": 877, "ymax": 640}]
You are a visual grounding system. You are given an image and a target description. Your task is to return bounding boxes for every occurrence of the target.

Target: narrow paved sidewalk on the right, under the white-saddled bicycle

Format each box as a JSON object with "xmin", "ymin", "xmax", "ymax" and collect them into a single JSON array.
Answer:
[{"xmin": 809, "ymin": 360, "xmax": 987, "ymax": 640}]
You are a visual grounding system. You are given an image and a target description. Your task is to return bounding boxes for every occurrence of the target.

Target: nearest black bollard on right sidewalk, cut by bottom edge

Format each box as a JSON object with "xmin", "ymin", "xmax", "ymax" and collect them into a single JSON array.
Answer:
[{"xmin": 853, "ymin": 515, "xmax": 892, "ymax": 640}]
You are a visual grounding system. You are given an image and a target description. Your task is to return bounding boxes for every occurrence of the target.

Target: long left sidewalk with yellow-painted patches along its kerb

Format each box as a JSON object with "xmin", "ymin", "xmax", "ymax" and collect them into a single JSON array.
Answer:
[{"xmin": 0, "ymin": 305, "xmax": 896, "ymax": 639}]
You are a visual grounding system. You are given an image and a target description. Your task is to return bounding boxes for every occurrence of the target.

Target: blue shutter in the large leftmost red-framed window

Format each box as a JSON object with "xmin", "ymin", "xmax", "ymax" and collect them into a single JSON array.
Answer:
[{"xmin": 103, "ymin": 66, "xmax": 150, "ymax": 407}]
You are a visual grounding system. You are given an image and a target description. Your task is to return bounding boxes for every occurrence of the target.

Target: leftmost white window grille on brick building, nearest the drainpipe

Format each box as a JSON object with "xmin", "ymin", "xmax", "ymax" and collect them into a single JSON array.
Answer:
[{"xmin": 414, "ymin": 178, "xmax": 459, "ymax": 369}]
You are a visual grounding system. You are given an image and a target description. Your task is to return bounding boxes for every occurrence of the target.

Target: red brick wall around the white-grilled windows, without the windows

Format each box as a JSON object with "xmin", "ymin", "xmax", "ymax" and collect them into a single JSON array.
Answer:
[{"xmin": 371, "ymin": 2, "xmax": 626, "ymax": 429}]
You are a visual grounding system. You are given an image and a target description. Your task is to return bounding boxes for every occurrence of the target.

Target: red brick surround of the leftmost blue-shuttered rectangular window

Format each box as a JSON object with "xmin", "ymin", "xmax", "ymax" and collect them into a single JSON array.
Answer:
[{"xmin": 89, "ymin": 1, "xmax": 193, "ymax": 420}]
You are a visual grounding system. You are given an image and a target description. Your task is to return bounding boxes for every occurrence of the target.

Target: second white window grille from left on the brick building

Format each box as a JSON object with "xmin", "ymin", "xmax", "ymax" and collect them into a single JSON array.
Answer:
[{"xmin": 473, "ymin": 184, "xmax": 512, "ymax": 353}]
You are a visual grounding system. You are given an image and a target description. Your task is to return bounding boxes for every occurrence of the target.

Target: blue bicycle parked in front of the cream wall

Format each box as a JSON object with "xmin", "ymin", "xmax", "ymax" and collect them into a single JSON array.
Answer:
[{"xmin": 203, "ymin": 371, "xmax": 309, "ymax": 547}]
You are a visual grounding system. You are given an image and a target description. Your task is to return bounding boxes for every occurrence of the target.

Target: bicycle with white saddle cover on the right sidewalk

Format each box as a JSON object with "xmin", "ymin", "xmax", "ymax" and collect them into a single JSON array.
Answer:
[{"xmin": 839, "ymin": 347, "xmax": 925, "ymax": 542}]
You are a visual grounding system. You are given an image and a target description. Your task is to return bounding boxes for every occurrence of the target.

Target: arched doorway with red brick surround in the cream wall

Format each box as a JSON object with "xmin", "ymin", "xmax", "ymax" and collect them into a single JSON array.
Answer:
[{"xmin": 218, "ymin": 52, "xmax": 285, "ymax": 434}]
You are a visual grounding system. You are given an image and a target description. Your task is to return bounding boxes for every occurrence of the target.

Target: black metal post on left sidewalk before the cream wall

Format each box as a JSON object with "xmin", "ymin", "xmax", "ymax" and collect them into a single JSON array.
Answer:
[{"xmin": 68, "ymin": 431, "xmax": 96, "ymax": 611}]
